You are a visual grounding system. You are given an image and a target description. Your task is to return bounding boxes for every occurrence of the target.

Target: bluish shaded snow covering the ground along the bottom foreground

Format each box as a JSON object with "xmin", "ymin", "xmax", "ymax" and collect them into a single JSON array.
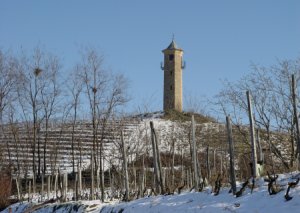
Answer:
[{"xmin": 2, "ymin": 173, "xmax": 300, "ymax": 213}]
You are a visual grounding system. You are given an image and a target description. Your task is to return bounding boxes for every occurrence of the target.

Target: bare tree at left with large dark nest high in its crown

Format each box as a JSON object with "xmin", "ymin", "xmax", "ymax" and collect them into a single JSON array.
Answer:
[{"xmin": 17, "ymin": 47, "xmax": 60, "ymax": 186}]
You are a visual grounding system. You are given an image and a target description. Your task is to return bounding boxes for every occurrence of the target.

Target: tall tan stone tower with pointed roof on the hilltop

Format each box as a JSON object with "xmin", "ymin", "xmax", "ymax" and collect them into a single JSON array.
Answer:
[{"xmin": 161, "ymin": 39, "xmax": 184, "ymax": 112}]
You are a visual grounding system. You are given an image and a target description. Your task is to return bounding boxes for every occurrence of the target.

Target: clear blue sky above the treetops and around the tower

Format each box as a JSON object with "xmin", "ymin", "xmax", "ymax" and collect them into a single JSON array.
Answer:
[{"xmin": 0, "ymin": 0, "xmax": 300, "ymax": 114}]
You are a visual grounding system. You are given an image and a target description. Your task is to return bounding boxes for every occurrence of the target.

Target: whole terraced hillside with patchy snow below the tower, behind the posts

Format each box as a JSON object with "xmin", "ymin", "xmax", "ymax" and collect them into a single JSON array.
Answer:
[{"xmin": 0, "ymin": 113, "xmax": 290, "ymax": 185}]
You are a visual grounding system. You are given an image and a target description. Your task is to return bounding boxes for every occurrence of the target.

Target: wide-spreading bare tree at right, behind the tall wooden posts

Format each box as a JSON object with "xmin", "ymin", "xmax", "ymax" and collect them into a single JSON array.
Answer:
[{"xmin": 218, "ymin": 60, "xmax": 300, "ymax": 173}]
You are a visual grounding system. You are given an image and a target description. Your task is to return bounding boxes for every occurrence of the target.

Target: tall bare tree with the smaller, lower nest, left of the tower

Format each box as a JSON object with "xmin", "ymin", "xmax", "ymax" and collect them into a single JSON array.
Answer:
[{"xmin": 79, "ymin": 48, "xmax": 128, "ymax": 201}]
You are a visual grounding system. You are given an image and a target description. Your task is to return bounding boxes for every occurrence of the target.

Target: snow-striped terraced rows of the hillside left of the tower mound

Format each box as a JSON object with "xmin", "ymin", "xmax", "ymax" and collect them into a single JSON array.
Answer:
[{"xmin": 0, "ymin": 119, "xmax": 140, "ymax": 176}]
